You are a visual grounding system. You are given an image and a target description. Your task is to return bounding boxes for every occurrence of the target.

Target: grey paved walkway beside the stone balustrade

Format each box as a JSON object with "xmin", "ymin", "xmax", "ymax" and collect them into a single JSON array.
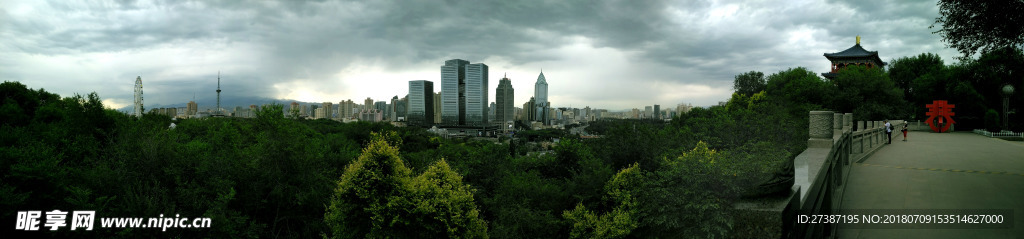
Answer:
[{"xmin": 838, "ymin": 131, "xmax": 1024, "ymax": 239}]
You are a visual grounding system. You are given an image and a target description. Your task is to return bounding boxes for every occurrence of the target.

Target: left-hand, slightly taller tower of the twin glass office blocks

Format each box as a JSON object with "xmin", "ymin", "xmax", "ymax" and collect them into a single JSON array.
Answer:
[{"xmin": 441, "ymin": 58, "xmax": 469, "ymax": 125}]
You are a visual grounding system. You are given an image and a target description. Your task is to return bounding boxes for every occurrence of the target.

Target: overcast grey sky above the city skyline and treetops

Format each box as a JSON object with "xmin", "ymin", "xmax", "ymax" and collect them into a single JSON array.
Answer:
[{"xmin": 0, "ymin": 0, "xmax": 957, "ymax": 110}]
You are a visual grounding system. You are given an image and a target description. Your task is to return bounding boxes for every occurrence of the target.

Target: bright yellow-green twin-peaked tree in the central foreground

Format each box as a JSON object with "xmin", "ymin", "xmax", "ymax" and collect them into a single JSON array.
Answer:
[{"xmin": 325, "ymin": 132, "xmax": 487, "ymax": 238}]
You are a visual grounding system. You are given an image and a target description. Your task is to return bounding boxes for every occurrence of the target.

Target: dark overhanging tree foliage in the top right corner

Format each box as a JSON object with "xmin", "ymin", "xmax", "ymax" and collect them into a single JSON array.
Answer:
[{"xmin": 931, "ymin": 0, "xmax": 1024, "ymax": 59}]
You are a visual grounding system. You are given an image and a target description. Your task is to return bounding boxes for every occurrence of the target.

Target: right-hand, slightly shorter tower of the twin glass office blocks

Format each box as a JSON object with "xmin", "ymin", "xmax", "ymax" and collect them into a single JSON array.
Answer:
[{"xmin": 465, "ymin": 63, "xmax": 490, "ymax": 125}]
